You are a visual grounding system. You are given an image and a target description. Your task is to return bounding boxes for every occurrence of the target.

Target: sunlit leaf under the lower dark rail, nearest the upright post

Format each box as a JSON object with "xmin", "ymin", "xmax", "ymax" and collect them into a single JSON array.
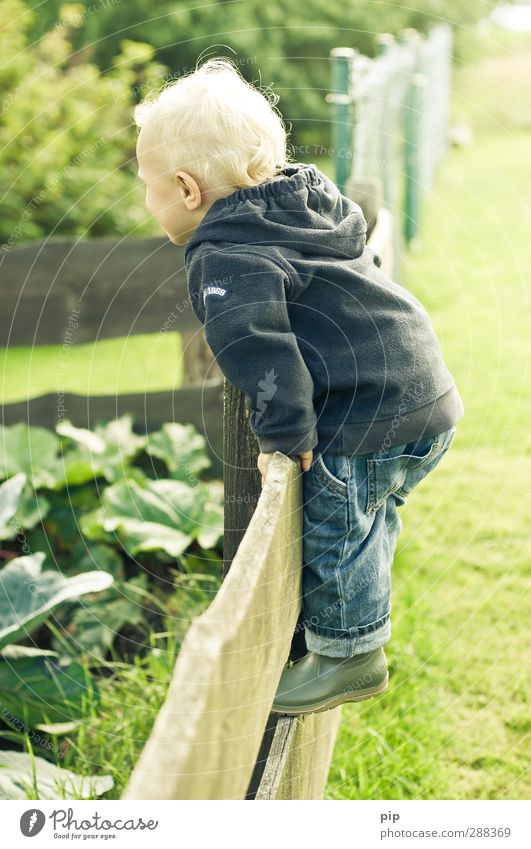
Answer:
[{"xmin": 146, "ymin": 422, "xmax": 211, "ymax": 486}]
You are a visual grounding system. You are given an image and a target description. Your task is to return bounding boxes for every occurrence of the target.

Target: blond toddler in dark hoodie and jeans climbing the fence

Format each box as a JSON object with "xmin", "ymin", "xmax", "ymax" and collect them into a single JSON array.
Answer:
[{"xmin": 135, "ymin": 58, "xmax": 464, "ymax": 715}]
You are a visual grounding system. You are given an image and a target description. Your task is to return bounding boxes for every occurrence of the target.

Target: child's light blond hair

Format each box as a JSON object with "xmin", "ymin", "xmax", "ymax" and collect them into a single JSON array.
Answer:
[{"xmin": 134, "ymin": 57, "xmax": 287, "ymax": 189}]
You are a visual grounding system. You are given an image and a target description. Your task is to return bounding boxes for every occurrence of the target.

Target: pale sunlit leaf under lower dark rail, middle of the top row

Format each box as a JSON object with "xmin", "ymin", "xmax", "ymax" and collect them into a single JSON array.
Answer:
[{"xmin": 57, "ymin": 416, "xmax": 146, "ymax": 483}]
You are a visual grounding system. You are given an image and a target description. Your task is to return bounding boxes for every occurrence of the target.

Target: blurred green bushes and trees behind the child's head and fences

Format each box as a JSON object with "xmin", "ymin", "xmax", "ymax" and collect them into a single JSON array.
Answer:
[{"xmin": 0, "ymin": 0, "xmax": 498, "ymax": 246}]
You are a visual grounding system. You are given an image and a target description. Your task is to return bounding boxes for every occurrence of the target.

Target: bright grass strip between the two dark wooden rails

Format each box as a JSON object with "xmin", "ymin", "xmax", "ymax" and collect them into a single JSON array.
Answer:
[{"xmin": 0, "ymin": 333, "xmax": 183, "ymax": 404}]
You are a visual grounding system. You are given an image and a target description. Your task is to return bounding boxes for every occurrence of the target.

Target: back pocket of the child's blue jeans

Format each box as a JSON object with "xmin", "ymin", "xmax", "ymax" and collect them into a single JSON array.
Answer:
[{"xmin": 365, "ymin": 427, "xmax": 455, "ymax": 513}]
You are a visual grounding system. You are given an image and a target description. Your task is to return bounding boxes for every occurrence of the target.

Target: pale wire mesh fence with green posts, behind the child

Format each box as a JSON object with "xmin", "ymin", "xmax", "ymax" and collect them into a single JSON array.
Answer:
[{"xmin": 327, "ymin": 24, "xmax": 452, "ymax": 248}]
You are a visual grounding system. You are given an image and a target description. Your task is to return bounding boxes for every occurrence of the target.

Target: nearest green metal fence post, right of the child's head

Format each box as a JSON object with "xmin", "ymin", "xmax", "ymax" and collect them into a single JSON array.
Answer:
[{"xmin": 326, "ymin": 47, "xmax": 356, "ymax": 193}]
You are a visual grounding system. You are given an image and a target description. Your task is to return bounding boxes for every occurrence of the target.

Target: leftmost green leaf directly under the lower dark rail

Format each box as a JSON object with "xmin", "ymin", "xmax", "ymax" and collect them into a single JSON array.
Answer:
[{"xmin": 0, "ymin": 422, "xmax": 64, "ymax": 489}]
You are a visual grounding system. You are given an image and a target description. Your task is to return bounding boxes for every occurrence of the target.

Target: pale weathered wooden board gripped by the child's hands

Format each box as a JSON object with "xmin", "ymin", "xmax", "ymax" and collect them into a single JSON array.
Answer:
[{"xmin": 122, "ymin": 452, "xmax": 338, "ymax": 799}]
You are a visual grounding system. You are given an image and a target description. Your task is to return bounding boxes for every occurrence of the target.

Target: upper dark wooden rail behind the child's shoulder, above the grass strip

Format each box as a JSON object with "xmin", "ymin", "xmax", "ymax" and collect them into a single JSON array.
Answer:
[{"xmin": 0, "ymin": 238, "xmax": 197, "ymax": 348}]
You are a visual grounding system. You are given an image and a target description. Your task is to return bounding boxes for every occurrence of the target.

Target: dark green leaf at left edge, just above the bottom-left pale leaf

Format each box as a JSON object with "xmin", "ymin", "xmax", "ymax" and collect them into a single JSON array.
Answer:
[{"xmin": 0, "ymin": 646, "xmax": 97, "ymax": 728}]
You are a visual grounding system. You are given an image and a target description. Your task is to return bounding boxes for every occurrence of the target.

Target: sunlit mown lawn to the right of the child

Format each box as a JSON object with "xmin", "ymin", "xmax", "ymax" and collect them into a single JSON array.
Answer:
[{"xmin": 326, "ymin": 29, "xmax": 531, "ymax": 799}]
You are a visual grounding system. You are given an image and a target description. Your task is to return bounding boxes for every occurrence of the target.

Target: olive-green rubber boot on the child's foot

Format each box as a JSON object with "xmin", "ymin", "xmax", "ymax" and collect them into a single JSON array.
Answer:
[{"xmin": 271, "ymin": 647, "xmax": 389, "ymax": 716}]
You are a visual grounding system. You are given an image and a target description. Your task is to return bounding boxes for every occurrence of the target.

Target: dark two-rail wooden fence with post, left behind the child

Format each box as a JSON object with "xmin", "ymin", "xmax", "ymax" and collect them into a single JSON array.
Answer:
[{"xmin": 0, "ymin": 238, "xmax": 223, "ymax": 478}]
